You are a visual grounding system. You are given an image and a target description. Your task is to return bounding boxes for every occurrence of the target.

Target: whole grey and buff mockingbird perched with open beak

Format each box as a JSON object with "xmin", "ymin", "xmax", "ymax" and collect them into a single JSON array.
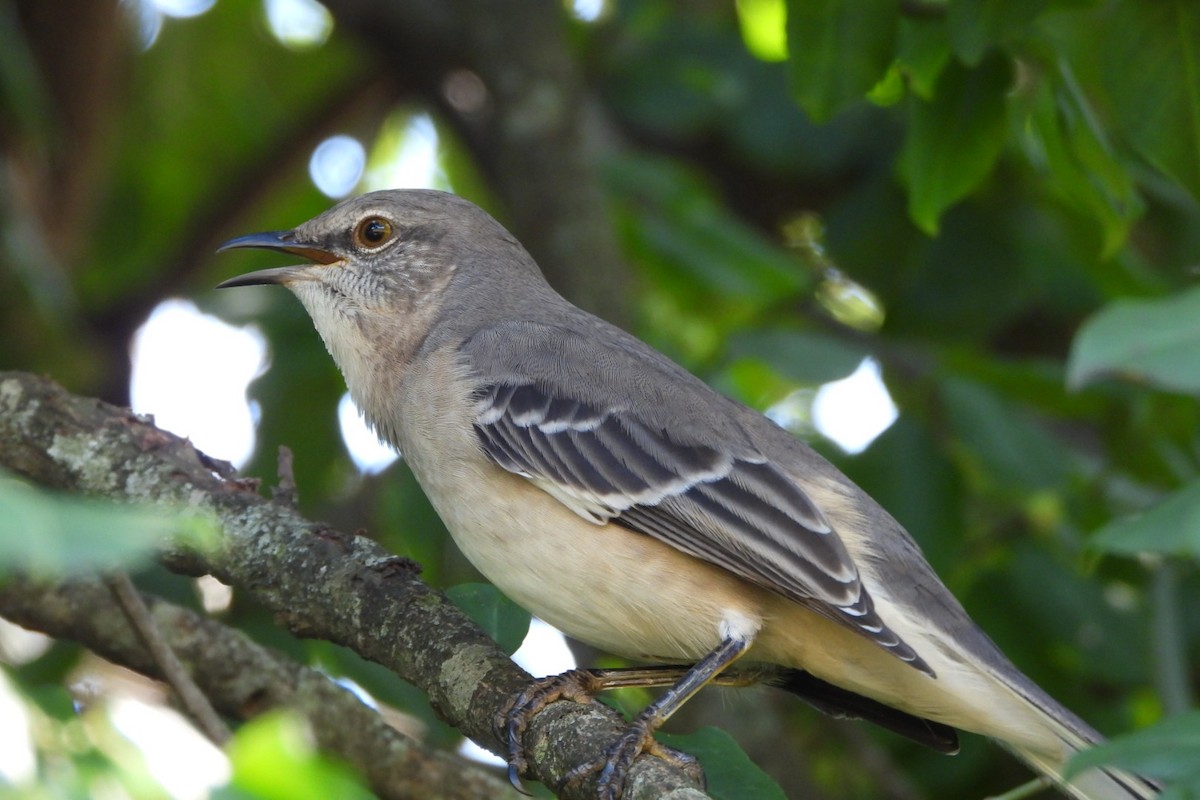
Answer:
[{"xmin": 221, "ymin": 191, "xmax": 1158, "ymax": 800}]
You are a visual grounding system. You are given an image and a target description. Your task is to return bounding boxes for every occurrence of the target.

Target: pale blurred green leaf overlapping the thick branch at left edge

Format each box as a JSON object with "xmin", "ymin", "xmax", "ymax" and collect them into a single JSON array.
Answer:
[{"xmin": 0, "ymin": 474, "xmax": 218, "ymax": 576}]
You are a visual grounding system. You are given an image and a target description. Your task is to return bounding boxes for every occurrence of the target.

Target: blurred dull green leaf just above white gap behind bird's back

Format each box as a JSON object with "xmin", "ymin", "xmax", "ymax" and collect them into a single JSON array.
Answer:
[{"xmin": 730, "ymin": 330, "xmax": 870, "ymax": 384}]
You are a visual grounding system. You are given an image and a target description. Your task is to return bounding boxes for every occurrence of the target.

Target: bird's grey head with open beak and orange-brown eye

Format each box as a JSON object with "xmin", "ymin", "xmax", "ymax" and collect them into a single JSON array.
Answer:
[{"xmin": 218, "ymin": 190, "xmax": 548, "ymax": 405}]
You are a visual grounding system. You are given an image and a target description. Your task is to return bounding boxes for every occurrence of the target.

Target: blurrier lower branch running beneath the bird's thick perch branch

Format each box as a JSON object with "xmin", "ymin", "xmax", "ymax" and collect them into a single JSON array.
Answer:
[{"xmin": 0, "ymin": 577, "xmax": 520, "ymax": 800}]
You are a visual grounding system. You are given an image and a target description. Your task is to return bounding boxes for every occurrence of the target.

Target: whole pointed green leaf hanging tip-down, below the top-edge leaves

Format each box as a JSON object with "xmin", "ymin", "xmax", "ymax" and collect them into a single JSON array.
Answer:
[{"xmin": 900, "ymin": 56, "xmax": 1012, "ymax": 235}]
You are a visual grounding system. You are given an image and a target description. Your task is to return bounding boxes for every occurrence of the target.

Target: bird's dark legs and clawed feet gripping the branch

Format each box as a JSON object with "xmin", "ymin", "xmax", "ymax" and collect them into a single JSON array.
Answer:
[{"xmin": 504, "ymin": 638, "xmax": 744, "ymax": 800}]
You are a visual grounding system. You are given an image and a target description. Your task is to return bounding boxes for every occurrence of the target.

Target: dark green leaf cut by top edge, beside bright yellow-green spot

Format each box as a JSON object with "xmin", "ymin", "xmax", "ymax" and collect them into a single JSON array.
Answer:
[{"xmin": 787, "ymin": 0, "xmax": 900, "ymax": 122}]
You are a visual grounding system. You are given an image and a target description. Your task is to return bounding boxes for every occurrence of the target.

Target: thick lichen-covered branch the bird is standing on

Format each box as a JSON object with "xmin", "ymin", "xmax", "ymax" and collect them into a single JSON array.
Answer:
[{"xmin": 0, "ymin": 372, "xmax": 704, "ymax": 800}]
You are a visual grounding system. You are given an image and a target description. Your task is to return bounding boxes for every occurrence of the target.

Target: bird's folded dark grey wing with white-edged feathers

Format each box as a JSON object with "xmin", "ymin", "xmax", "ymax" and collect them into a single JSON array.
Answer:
[{"xmin": 475, "ymin": 380, "xmax": 932, "ymax": 674}]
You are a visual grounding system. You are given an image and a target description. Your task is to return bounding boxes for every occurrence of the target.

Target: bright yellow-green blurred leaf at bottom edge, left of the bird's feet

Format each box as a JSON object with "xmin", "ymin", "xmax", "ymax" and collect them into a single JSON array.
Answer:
[{"xmin": 223, "ymin": 711, "xmax": 374, "ymax": 800}]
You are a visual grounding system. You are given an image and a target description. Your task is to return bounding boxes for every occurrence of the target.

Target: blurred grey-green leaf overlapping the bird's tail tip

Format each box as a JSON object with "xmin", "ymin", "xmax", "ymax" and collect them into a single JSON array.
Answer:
[{"xmin": 1066, "ymin": 711, "xmax": 1200, "ymax": 786}]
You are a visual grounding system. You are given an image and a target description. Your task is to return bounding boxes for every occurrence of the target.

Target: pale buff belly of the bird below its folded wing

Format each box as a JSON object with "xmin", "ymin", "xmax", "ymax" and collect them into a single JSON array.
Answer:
[{"xmin": 434, "ymin": 455, "xmax": 766, "ymax": 661}]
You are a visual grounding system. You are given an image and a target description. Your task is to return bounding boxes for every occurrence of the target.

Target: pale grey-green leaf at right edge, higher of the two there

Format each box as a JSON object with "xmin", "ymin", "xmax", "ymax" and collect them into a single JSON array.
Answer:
[{"xmin": 1067, "ymin": 287, "xmax": 1200, "ymax": 395}]
